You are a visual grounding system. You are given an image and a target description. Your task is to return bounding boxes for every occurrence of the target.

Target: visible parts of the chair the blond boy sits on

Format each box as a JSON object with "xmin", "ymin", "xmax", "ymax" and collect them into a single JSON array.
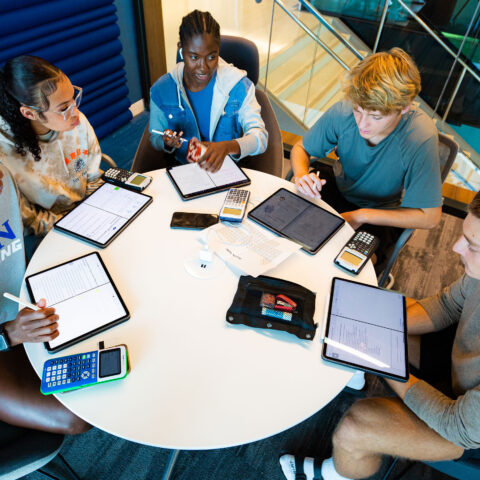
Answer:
[{"xmin": 378, "ymin": 132, "xmax": 458, "ymax": 287}]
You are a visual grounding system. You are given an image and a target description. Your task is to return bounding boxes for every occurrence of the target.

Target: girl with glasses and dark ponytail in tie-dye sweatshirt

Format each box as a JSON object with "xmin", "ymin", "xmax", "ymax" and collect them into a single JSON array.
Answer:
[{"xmin": 0, "ymin": 55, "xmax": 101, "ymax": 235}]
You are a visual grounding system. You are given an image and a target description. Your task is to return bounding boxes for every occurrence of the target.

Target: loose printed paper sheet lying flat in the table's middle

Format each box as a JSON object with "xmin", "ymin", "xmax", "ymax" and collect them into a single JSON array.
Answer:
[{"xmin": 200, "ymin": 222, "xmax": 300, "ymax": 277}]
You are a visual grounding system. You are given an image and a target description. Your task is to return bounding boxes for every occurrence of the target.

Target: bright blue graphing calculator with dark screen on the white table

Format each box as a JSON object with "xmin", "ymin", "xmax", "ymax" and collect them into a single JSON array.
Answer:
[{"xmin": 40, "ymin": 345, "xmax": 128, "ymax": 395}]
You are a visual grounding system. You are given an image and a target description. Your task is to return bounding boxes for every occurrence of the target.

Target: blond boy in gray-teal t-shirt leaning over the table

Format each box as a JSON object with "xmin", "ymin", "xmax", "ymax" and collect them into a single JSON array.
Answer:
[{"xmin": 290, "ymin": 48, "xmax": 442, "ymax": 273}]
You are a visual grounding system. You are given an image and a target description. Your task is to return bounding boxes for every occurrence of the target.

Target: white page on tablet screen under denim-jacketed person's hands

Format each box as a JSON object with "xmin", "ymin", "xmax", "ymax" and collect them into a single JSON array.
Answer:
[{"xmin": 169, "ymin": 155, "xmax": 247, "ymax": 195}]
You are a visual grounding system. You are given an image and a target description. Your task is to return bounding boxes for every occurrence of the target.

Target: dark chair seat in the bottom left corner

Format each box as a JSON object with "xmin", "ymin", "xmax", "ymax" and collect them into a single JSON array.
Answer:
[{"xmin": 0, "ymin": 421, "xmax": 79, "ymax": 480}]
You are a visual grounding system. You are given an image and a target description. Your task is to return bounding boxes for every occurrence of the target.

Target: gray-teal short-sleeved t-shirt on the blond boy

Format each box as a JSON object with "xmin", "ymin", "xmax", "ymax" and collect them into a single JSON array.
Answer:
[{"xmin": 303, "ymin": 100, "xmax": 442, "ymax": 208}]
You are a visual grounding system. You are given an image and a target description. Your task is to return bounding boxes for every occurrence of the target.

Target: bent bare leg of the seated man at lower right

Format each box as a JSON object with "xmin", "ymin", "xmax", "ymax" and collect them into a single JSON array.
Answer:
[{"xmin": 333, "ymin": 398, "xmax": 463, "ymax": 479}]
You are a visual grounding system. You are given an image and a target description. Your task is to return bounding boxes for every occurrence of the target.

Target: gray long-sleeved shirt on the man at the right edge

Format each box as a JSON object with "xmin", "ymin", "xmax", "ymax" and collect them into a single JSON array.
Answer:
[{"xmin": 404, "ymin": 275, "xmax": 480, "ymax": 448}]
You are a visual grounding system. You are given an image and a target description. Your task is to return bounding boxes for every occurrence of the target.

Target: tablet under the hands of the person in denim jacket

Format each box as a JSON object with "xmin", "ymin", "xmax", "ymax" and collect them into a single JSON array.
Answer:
[{"xmin": 167, "ymin": 155, "xmax": 250, "ymax": 200}]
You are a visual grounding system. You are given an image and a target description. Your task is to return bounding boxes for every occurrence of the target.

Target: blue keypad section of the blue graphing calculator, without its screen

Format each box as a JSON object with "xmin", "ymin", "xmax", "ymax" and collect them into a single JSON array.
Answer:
[{"xmin": 41, "ymin": 351, "xmax": 98, "ymax": 393}]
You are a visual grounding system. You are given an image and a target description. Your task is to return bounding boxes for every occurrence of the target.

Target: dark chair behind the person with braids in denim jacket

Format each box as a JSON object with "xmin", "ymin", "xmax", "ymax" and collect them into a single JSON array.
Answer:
[{"xmin": 132, "ymin": 35, "xmax": 283, "ymax": 177}]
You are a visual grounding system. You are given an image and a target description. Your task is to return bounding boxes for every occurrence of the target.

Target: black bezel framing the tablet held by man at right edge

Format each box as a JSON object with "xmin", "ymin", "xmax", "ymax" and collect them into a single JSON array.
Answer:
[{"xmin": 322, "ymin": 277, "xmax": 409, "ymax": 383}]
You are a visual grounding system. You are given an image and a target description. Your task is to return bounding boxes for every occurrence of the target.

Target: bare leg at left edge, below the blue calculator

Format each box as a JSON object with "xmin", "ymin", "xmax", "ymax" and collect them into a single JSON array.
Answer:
[{"xmin": 0, "ymin": 347, "xmax": 91, "ymax": 435}]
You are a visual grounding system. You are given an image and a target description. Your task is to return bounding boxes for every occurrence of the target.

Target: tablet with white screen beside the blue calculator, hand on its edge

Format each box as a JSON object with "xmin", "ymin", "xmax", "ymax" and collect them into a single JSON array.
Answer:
[{"xmin": 25, "ymin": 252, "xmax": 130, "ymax": 353}]
